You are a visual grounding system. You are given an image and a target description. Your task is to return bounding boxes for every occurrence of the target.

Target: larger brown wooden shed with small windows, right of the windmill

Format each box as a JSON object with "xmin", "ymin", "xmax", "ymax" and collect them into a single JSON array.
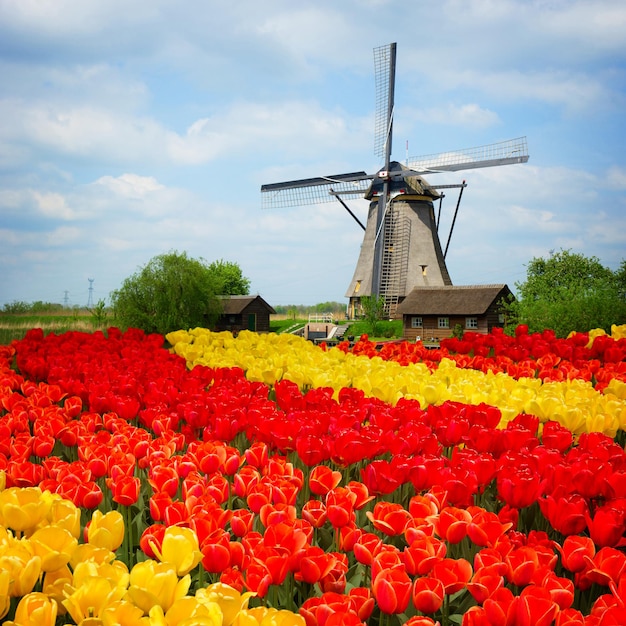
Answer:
[{"xmin": 397, "ymin": 285, "xmax": 513, "ymax": 341}]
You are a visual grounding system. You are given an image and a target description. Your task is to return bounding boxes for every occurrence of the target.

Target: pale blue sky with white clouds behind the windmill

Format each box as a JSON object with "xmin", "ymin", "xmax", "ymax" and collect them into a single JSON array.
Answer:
[{"xmin": 0, "ymin": 0, "xmax": 626, "ymax": 306}]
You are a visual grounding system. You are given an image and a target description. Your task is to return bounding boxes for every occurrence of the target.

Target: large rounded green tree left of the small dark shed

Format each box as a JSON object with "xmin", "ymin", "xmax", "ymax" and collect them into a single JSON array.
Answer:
[{"xmin": 111, "ymin": 252, "xmax": 241, "ymax": 334}]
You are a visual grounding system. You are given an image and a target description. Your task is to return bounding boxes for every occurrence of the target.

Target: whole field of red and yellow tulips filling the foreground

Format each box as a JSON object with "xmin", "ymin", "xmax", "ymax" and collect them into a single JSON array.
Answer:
[{"xmin": 0, "ymin": 325, "xmax": 626, "ymax": 626}]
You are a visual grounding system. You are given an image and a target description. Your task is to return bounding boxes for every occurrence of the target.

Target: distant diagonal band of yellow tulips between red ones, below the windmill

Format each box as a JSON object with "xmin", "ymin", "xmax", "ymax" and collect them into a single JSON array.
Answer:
[{"xmin": 166, "ymin": 325, "xmax": 626, "ymax": 435}]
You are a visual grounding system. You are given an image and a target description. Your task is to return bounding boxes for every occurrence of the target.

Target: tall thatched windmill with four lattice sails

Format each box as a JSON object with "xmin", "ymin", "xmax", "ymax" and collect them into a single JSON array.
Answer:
[{"xmin": 261, "ymin": 43, "xmax": 528, "ymax": 317}]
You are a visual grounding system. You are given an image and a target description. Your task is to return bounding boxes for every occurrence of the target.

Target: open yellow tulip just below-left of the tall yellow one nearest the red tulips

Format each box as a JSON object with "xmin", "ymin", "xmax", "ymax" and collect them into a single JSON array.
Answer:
[{"xmin": 128, "ymin": 559, "xmax": 191, "ymax": 614}]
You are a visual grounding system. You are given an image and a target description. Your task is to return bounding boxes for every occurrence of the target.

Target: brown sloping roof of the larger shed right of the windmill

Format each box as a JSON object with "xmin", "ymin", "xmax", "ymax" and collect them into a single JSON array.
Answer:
[{"xmin": 397, "ymin": 285, "xmax": 511, "ymax": 315}]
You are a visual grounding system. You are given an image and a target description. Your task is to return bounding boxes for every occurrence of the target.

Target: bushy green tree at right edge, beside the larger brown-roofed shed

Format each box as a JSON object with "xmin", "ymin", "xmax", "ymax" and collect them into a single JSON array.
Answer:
[{"xmin": 508, "ymin": 250, "xmax": 626, "ymax": 337}]
